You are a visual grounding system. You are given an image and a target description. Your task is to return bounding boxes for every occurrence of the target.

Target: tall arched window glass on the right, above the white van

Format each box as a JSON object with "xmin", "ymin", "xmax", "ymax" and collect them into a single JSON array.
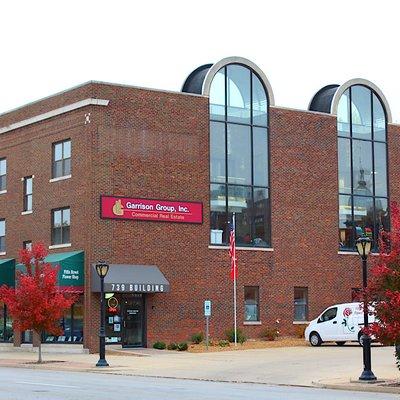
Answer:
[{"xmin": 337, "ymin": 85, "xmax": 389, "ymax": 251}]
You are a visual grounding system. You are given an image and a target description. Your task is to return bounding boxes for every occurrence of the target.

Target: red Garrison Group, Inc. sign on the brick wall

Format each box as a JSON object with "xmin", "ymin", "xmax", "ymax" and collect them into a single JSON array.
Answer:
[{"xmin": 100, "ymin": 196, "xmax": 203, "ymax": 224}]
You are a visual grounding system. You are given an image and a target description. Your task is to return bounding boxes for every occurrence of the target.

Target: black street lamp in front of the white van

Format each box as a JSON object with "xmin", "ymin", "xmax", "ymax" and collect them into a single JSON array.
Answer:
[{"xmin": 356, "ymin": 237, "xmax": 376, "ymax": 381}]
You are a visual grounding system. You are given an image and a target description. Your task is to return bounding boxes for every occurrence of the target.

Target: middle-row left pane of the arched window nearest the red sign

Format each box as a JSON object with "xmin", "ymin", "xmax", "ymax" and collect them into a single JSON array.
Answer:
[{"xmin": 210, "ymin": 122, "xmax": 226, "ymax": 182}]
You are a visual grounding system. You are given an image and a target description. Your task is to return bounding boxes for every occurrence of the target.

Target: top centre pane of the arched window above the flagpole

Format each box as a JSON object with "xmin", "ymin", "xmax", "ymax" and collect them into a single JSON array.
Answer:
[{"xmin": 227, "ymin": 65, "xmax": 251, "ymax": 124}]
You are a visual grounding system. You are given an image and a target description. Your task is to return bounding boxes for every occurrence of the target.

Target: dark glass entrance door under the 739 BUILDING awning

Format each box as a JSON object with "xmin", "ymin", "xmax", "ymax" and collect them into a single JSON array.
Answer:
[{"xmin": 122, "ymin": 294, "xmax": 145, "ymax": 347}]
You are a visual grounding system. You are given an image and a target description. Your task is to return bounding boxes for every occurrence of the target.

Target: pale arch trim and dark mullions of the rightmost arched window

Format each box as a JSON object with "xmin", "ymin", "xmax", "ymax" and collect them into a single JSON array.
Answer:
[{"xmin": 331, "ymin": 79, "xmax": 392, "ymax": 252}]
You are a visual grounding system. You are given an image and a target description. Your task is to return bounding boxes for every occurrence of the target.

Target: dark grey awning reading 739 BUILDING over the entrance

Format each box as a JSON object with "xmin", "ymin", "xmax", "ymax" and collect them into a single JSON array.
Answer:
[{"xmin": 91, "ymin": 264, "xmax": 170, "ymax": 293}]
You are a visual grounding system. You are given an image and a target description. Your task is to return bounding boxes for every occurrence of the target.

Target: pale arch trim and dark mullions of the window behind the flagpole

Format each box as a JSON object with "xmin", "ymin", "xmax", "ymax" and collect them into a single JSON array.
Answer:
[{"xmin": 203, "ymin": 57, "xmax": 274, "ymax": 247}]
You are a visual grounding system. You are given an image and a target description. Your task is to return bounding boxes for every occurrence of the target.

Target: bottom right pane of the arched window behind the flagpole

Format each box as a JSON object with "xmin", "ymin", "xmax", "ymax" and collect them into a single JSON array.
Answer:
[{"xmin": 253, "ymin": 188, "xmax": 271, "ymax": 247}]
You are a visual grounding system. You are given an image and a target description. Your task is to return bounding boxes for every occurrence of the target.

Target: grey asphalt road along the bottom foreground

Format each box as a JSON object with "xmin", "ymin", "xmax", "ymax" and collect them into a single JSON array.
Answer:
[{"xmin": 0, "ymin": 368, "xmax": 398, "ymax": 400}]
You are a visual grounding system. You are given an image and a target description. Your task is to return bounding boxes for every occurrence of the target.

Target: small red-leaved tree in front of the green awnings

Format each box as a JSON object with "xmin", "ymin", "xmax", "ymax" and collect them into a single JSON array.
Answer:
[{"xmin": 0, "ymin": 243, "xmax": 76, "ymax": 363}]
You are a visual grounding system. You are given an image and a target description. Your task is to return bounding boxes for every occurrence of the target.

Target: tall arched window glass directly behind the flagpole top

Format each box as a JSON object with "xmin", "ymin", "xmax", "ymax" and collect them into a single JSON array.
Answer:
[{"xmin": 210, "ymin": 63, "xmax": 271, "ymax": 247}]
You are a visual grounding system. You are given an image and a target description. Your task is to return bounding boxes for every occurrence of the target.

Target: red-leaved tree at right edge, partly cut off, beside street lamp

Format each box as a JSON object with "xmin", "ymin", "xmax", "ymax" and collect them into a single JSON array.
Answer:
[{"xmin": 365, "ymin": 202, "xmax": 400, "ymax": 369}]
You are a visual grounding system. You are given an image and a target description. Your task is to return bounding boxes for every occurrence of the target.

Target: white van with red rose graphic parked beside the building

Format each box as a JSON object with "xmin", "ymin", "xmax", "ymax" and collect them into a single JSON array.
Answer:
[{"xmin": 304, "ymin": 303, "xmax": 375, "ymax": 346}]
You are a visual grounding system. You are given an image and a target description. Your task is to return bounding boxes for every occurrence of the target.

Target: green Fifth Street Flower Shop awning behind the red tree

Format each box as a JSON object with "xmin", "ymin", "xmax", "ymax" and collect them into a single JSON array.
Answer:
[{"xmin": 17, "ymin": 251, "xmax": 85, "ymax": 293}]
